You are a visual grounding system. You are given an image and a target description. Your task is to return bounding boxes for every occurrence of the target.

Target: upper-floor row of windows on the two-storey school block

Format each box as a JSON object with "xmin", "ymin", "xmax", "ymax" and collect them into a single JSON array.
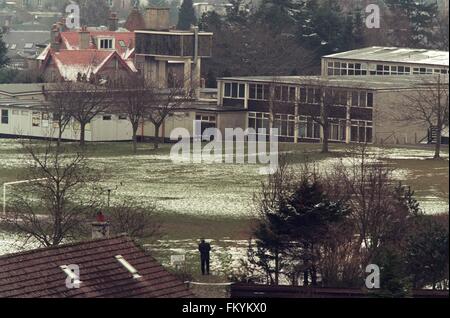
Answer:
[{"xmin": 224, "ymin": 83, "xmax": 373, "ymax": 107}]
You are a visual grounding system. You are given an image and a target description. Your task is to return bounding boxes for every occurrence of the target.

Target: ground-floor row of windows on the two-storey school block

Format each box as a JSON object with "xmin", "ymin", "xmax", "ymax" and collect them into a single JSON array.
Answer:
[{"xmin": 248, "ymin": 112, "xmax": 373, "ymax": 143}]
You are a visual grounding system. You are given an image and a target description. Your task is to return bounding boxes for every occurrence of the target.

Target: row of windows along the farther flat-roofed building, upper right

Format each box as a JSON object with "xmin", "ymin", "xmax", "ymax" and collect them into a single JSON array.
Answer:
[{"xmin": 328, "ymin": 62, "xmax": 448, "ymax": 76}]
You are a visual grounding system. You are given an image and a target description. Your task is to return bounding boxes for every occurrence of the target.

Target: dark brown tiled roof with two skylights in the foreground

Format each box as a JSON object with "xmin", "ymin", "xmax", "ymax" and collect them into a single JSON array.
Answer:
[{"xmin": 0, "ymin": 236, "xmax": 193, "ymax": 298}]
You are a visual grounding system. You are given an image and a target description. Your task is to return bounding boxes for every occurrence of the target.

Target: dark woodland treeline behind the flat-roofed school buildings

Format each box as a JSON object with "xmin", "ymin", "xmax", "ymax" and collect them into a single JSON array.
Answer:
[{"xmin": 198, "ymin": 0, "xmax": 448, "ymax": 87}]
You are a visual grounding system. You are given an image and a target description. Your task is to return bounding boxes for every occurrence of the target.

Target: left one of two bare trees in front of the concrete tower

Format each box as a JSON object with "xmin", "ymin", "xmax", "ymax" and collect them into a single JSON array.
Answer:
[{"xmin": 112, "ymin": 74, "xmax": 157, "ymax": 153}]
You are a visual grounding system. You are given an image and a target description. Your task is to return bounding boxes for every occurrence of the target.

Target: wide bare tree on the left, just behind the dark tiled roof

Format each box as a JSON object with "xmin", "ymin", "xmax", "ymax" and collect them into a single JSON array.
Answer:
[{"xmin": 3, "ymin": 141, "xmax": 102, "ymax": 246}]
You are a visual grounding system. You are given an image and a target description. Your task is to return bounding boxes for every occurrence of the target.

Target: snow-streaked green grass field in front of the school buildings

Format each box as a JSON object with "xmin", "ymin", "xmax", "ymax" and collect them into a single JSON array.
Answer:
[{"xmin": 0, "ymin": 139, "xmax": 449, "ymax": 278}]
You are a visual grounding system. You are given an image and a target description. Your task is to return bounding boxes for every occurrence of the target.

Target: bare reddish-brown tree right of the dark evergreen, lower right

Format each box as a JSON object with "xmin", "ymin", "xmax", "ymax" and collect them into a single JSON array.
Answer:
[{"xmin": 328, "ymin": 145, "xmax": 409, "ymax": 264}]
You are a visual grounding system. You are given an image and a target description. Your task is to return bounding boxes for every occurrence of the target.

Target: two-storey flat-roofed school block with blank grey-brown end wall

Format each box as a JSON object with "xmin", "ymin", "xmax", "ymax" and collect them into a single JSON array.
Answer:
[{"xmin": 217, "ymin": 76, "xmax": 448, "ymax": 144}]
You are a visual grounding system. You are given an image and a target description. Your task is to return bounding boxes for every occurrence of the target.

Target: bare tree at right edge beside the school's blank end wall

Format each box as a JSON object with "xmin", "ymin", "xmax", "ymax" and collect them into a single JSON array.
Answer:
[{"xmin": 393, "ymin": 75, "xmax": 449, "ymax": 159}]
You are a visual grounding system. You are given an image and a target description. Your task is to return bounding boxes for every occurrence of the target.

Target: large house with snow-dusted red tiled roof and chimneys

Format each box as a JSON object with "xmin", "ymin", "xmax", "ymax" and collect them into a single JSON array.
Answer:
[{"xmin": 36, "ymin": 13, "xmax": 137, "ymax": 82}]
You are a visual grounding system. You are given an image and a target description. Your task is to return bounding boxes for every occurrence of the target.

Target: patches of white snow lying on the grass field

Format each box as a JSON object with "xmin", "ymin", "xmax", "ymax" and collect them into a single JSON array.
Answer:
[{"xmin": 0, "ymin": 139, "xmax": 448, "ymax": 259}]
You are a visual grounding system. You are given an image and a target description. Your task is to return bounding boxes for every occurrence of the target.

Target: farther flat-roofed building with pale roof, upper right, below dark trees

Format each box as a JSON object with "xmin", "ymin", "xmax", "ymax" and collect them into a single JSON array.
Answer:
[{"xmin": 322, "ymin": 46, "xmax": 449, "ymax": 76}]
